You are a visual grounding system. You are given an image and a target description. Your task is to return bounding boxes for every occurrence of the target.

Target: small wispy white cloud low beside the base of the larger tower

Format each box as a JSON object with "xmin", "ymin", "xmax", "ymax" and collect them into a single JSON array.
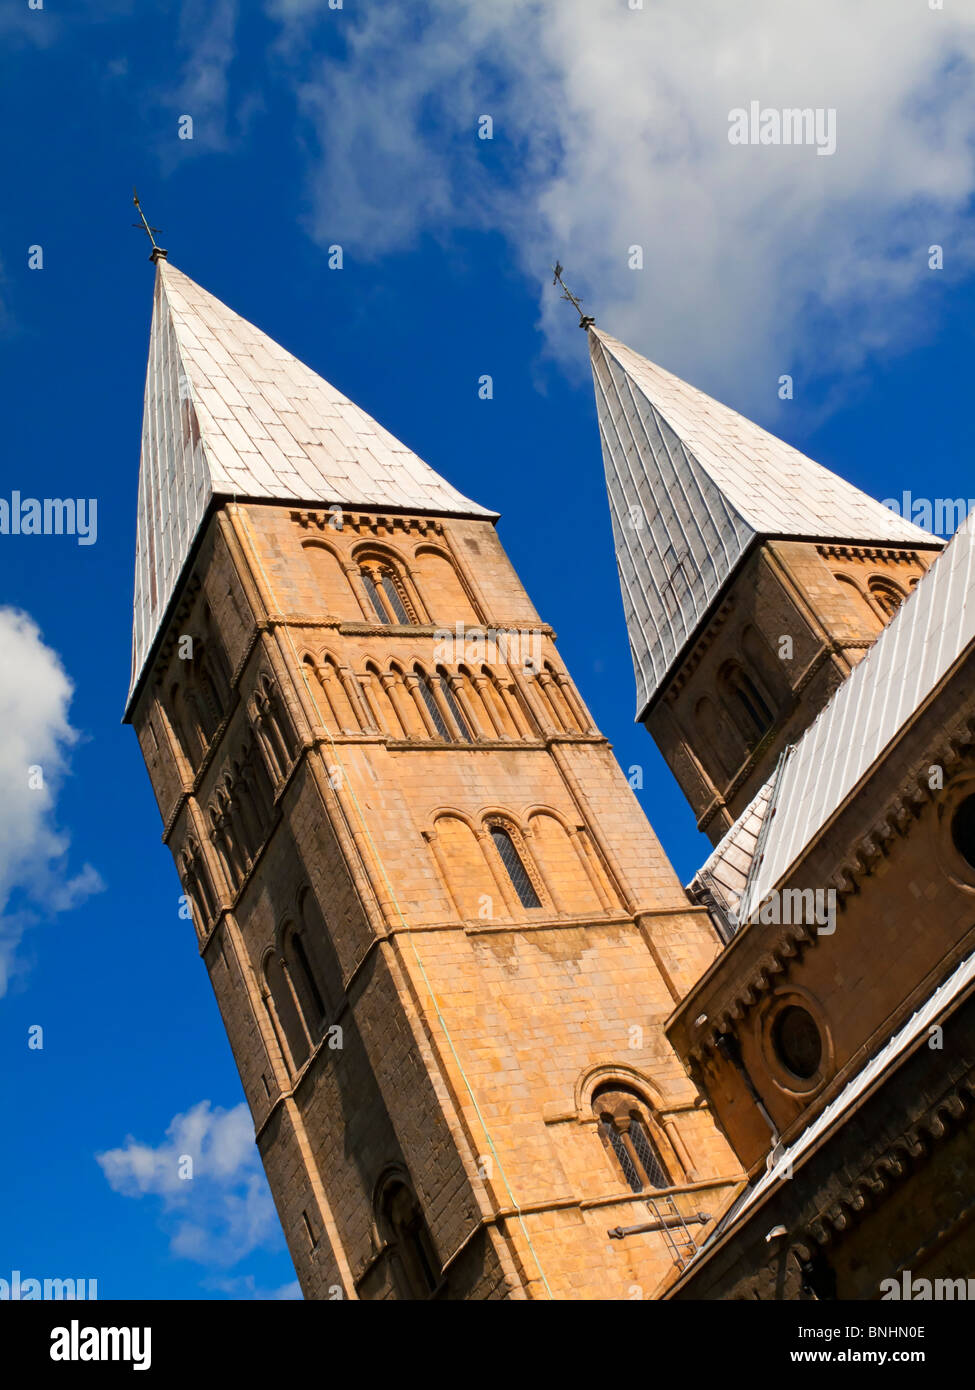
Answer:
[{"xmin": 96, "ymin": 1101, "xmax": 281, "ymax": 1273}]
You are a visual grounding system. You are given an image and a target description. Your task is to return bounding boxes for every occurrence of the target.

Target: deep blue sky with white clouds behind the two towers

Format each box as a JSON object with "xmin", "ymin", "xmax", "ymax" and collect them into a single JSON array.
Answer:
[{"xmin": 0, "ymin": 0, "xmax": 975, "ymax": 1298}]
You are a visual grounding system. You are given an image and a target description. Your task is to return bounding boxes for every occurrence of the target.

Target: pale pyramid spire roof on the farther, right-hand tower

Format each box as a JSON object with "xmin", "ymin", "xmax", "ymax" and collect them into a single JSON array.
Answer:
[{"xmin": 590, "ymin": 328, "xmax": 942, "ymax": 719}]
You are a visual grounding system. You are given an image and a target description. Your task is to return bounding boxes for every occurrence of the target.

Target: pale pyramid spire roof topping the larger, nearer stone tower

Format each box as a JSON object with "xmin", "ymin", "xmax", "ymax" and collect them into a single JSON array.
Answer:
[{"xmin": 128, "ymin": 259, "xmax": 497, "ymax": 706}]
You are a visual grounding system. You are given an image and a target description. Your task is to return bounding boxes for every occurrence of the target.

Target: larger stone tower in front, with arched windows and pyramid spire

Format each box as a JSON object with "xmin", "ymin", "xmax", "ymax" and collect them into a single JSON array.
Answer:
[{"xmin": 127, "ymin": 253, "xmax": 740, "ymax": 1298}]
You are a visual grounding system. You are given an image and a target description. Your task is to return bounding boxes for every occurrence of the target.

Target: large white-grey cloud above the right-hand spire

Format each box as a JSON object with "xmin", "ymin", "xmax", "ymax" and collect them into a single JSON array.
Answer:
[{"xmin": 268, "ymin": 0, "xmax": 975, "ymax": 399}]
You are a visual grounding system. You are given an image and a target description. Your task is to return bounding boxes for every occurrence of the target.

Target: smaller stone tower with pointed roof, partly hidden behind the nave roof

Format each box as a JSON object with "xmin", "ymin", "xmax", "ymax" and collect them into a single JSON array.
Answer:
[{"xmin": 590, "ymin": 328, "xmax": 943, "ymax": 842}]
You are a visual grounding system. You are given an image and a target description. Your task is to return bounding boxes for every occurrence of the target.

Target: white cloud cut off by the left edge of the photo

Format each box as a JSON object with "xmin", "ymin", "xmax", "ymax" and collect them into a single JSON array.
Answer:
[{"xmin": 0, "ymin": 607, "xmax": 103, "ymax": 995}]
